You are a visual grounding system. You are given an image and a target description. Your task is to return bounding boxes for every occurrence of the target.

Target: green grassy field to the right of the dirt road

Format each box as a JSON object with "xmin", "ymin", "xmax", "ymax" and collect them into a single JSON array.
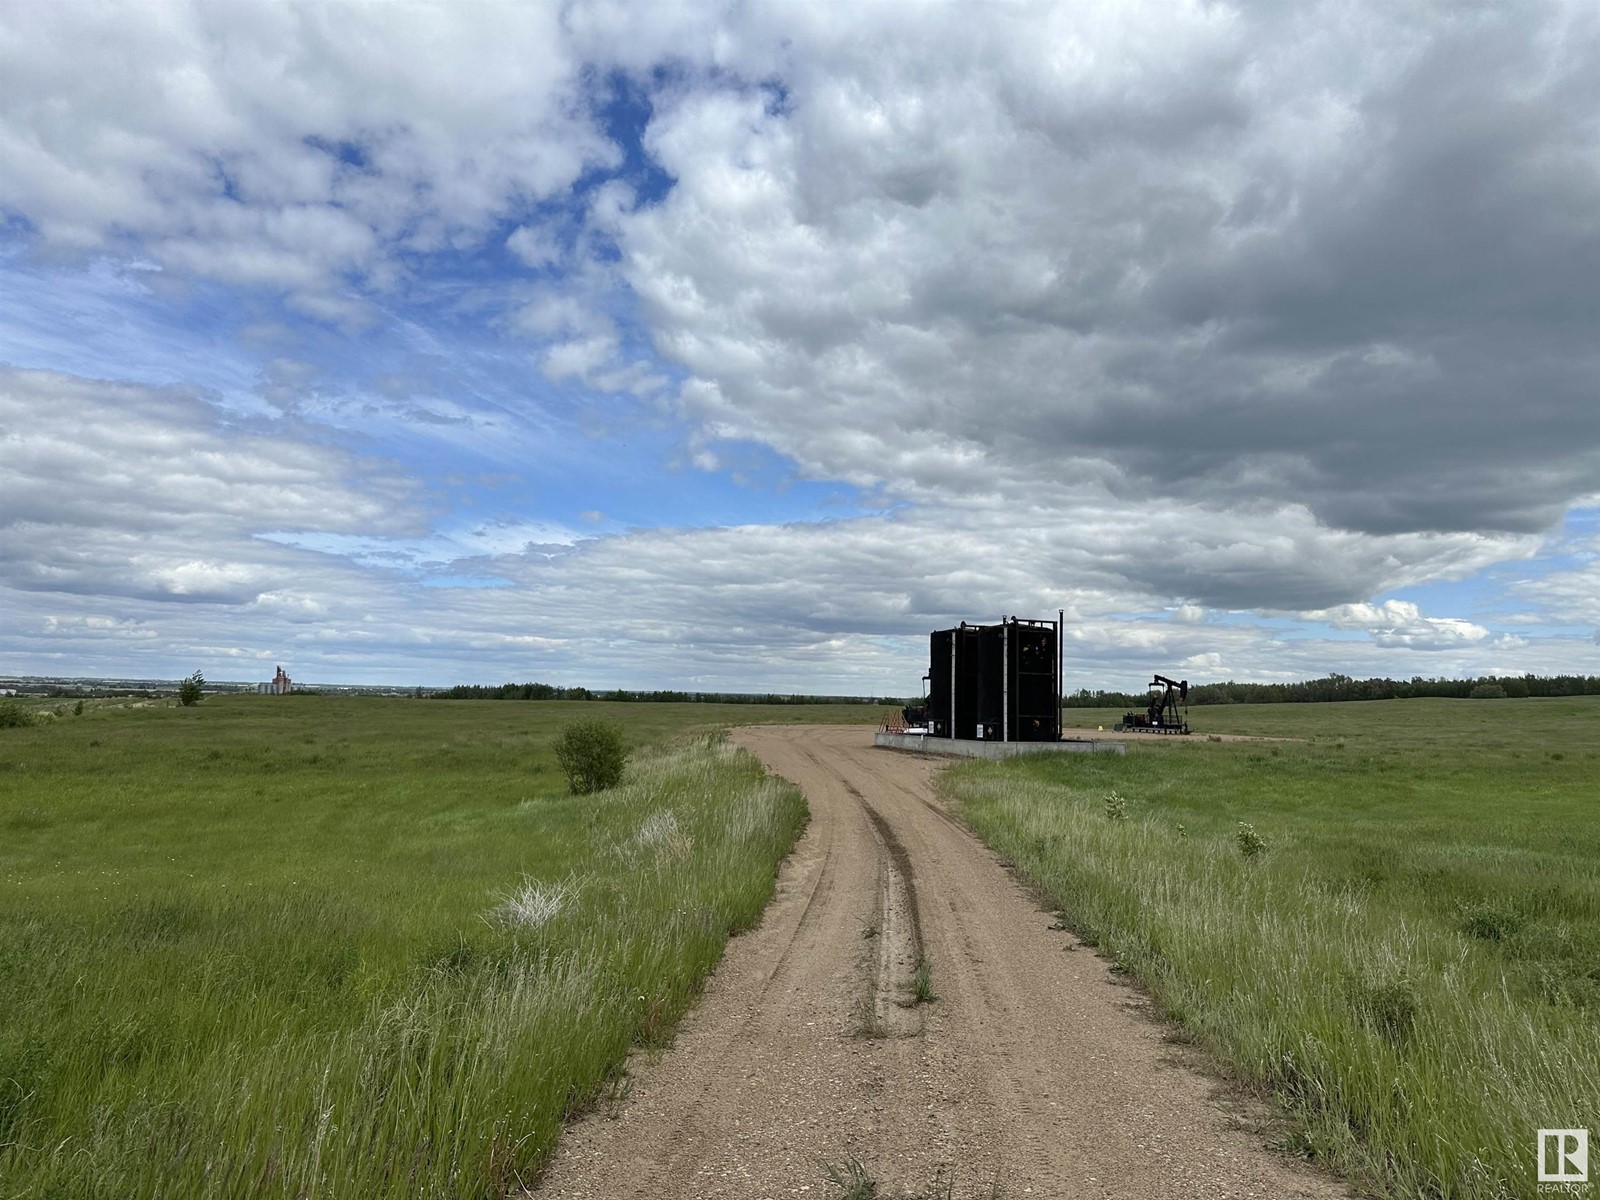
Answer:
[{"xmin": 942, "ymin": 698, "xmax": 1600, "ymax": 1200}]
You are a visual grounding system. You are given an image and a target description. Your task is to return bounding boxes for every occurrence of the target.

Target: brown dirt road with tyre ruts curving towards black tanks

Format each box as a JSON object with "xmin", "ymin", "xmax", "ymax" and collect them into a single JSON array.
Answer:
[{"xmin": 536, "ymin": 726, "xmax": 1346, "ymax": 1200}]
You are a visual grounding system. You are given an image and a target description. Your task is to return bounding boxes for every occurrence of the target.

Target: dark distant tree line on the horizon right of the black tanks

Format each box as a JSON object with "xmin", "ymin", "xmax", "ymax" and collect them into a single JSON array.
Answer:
[{"xmin": 1061, "ymin": 675, "xmax": 1600, "ymax": 709}]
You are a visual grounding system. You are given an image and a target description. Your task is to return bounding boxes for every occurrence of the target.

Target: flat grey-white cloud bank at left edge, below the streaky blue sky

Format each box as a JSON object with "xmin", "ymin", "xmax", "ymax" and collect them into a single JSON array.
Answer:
[{"xmin": 0, "ymin": 370, "xmax": 418, "ymax": 602}]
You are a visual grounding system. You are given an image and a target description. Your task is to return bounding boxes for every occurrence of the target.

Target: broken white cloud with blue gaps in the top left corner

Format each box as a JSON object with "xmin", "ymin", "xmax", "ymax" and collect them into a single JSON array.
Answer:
[{"xmin": 0, "ymin": 0, "xmax": 616, "ymax": 322}]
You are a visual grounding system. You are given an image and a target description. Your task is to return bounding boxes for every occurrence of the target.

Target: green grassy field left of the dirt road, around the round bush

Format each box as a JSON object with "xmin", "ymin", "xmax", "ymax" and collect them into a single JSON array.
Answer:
[{"xmin": 0, "ymin": 696, "xmax": 877, "ymax": 1200}]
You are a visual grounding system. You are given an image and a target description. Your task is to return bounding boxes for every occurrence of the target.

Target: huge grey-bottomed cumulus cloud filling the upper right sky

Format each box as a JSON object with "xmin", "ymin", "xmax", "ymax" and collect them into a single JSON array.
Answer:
[{"xmin": 601, "ymin": 3, "xmax": 1600, "ymax": 550}]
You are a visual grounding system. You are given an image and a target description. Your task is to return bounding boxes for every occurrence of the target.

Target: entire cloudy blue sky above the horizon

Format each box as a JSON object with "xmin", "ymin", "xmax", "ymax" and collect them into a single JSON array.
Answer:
[{"xmin": 0, "ymin": 0, "xmax": 1600, "ymax": 694}]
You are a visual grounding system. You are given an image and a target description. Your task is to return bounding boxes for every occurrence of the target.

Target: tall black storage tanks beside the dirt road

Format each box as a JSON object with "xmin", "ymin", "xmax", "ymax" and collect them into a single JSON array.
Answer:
[{"xmin": 906, "ymin": 613, "xmax": 1066, "ymax": 742}]
